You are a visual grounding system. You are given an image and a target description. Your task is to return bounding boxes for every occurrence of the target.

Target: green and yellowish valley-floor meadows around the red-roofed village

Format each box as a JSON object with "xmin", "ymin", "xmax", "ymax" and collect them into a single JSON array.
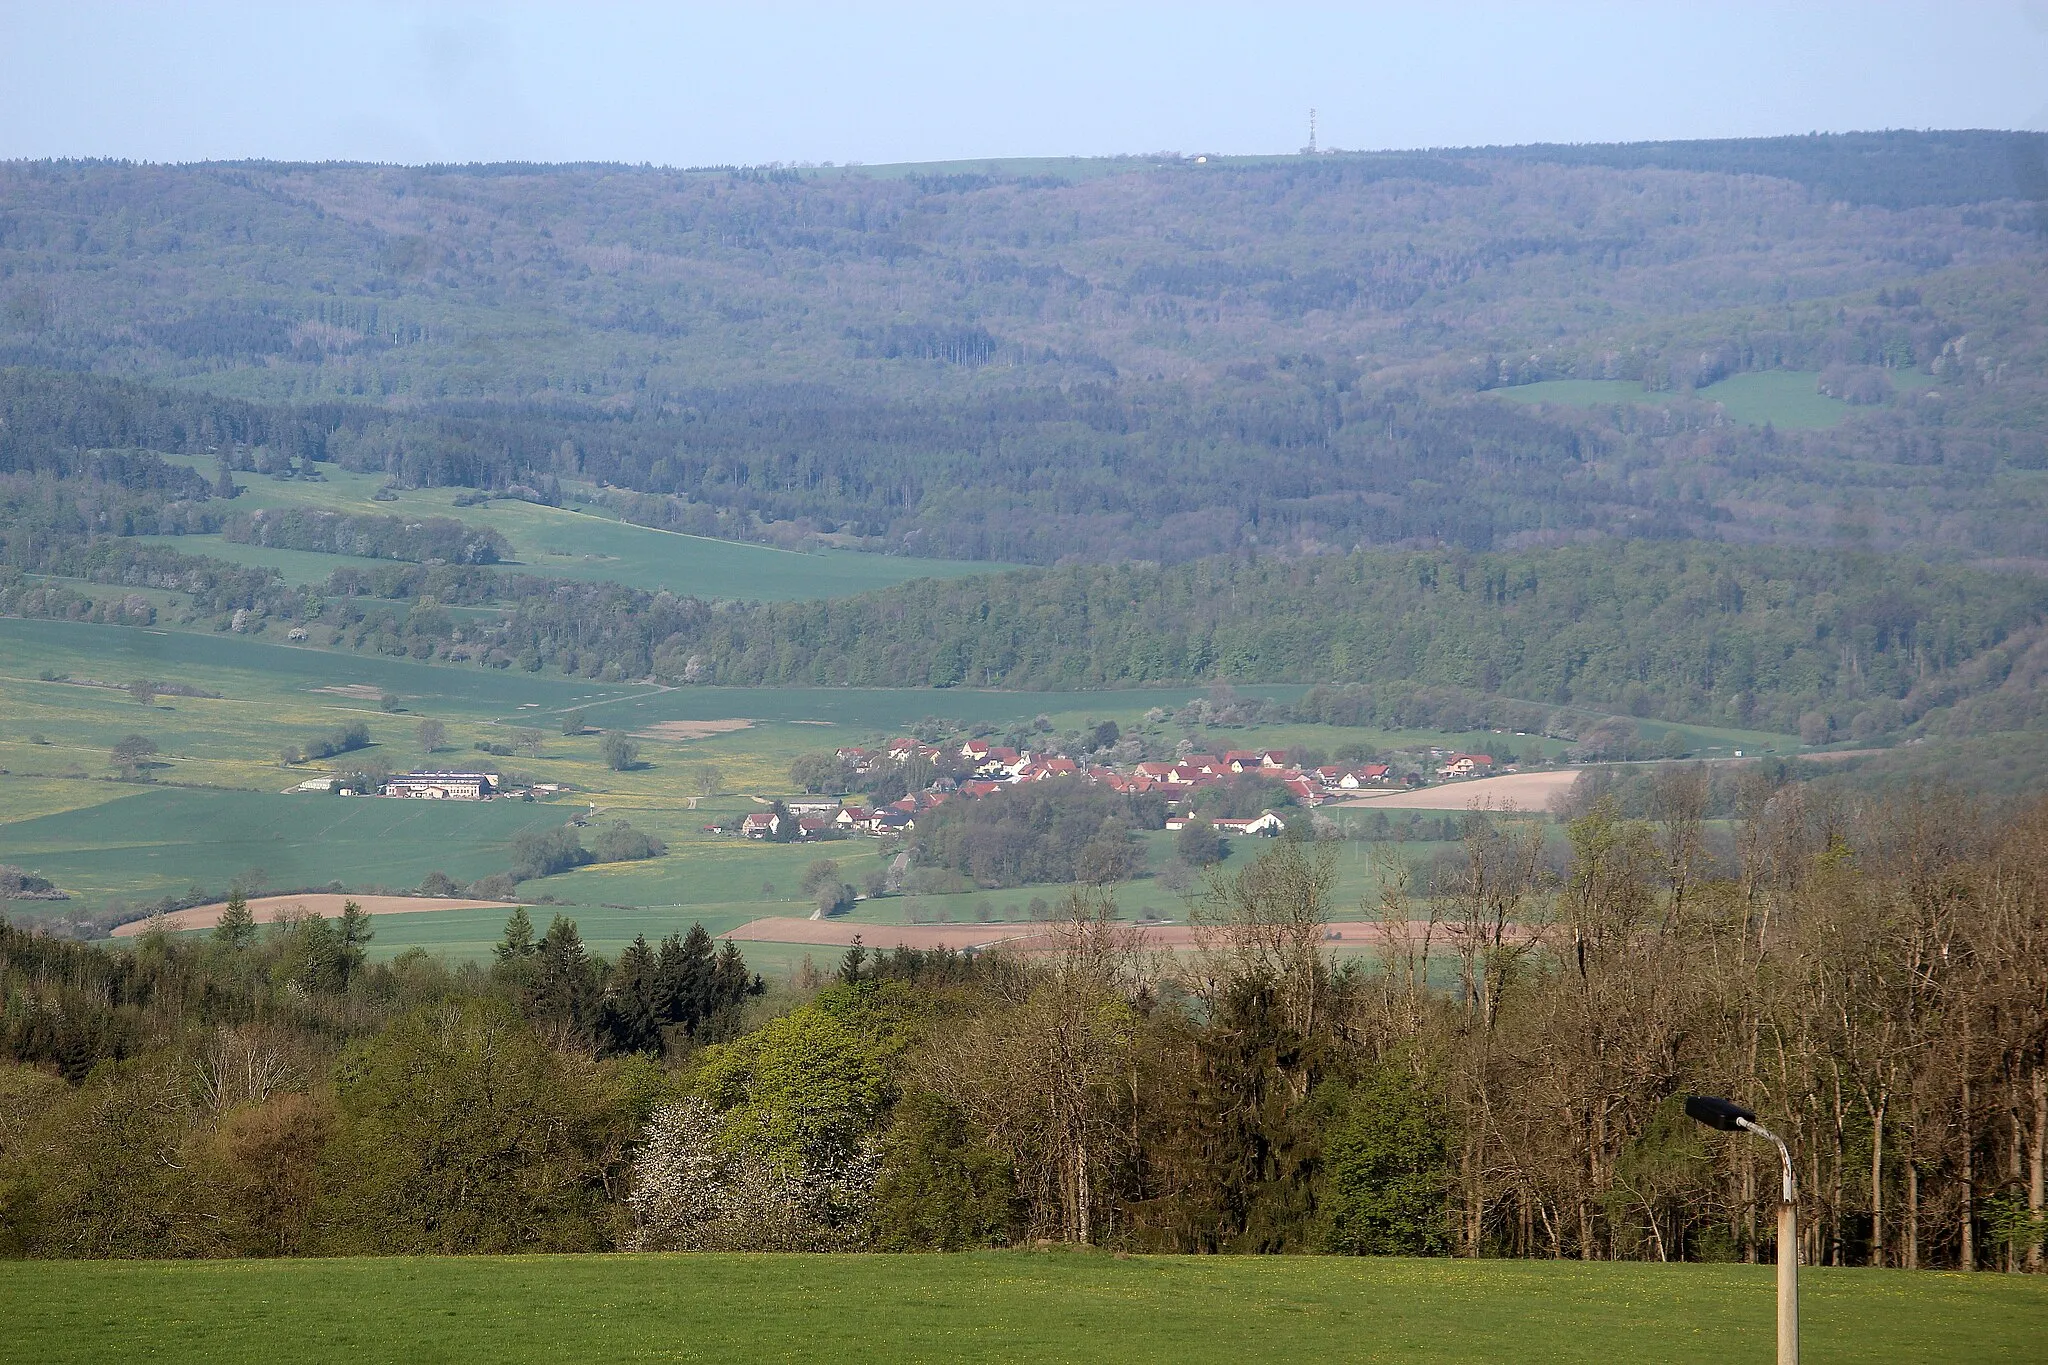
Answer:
[{"xmin": 0, "ymin": 620, "xmax": 1796, "ymax": 970}]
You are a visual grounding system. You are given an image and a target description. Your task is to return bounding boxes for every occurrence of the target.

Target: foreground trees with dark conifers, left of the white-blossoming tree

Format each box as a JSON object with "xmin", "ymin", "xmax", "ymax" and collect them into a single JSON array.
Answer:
[{"xmin": 0, "ymin": 896, "xmax": 762, "ymax": 1257}]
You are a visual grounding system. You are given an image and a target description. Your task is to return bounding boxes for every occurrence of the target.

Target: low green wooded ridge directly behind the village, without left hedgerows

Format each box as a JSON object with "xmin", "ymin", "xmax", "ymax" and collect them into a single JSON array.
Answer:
[{"xmin": 448, "ymin": 542, "xmax": 2048, "ymax": 731}]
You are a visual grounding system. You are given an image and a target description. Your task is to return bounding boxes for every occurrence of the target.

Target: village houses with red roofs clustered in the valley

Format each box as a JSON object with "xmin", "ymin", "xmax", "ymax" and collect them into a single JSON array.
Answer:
[{"xmin": 739, "ymin": 739, "xmax": 1493, "ymax": 839}]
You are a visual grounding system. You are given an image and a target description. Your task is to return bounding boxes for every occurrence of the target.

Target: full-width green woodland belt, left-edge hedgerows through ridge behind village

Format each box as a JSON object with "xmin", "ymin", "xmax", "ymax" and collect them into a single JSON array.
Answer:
[{"xmin": 12, "ymin": 485, "xmax": 2048, "ymax": 743}]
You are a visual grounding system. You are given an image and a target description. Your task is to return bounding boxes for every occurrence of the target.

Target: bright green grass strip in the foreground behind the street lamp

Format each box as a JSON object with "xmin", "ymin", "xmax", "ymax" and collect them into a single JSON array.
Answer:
[{"xmin": 0, "ymin": 1252, "xmax": 2048, "ymax": 1365}]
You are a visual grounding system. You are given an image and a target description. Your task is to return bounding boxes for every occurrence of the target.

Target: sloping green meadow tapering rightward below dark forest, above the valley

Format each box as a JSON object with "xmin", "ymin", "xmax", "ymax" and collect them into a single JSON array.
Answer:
[{"xmin": 141, "ymin": 456, "xmax": 1010, "ymax": 602}]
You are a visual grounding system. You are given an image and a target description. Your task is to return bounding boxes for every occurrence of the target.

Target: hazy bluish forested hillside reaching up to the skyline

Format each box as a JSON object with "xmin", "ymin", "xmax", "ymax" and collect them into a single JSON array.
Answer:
[{"xmin": 0, "ymin": 133, "xmax": 2048, "ymax": 563}]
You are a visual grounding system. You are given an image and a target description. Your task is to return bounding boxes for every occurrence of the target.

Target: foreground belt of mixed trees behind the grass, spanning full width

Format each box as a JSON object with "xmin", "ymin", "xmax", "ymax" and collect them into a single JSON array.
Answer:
[{"xmin": 0, "ymin": 785, "xmax": 2048, "ymax": 1271}]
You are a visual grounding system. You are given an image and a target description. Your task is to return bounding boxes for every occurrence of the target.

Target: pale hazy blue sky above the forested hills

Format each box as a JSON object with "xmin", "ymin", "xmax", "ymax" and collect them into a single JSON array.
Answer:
[{"xmin": 12, "ymin": 0, "xmax": 2048, "ymax": 166}]
